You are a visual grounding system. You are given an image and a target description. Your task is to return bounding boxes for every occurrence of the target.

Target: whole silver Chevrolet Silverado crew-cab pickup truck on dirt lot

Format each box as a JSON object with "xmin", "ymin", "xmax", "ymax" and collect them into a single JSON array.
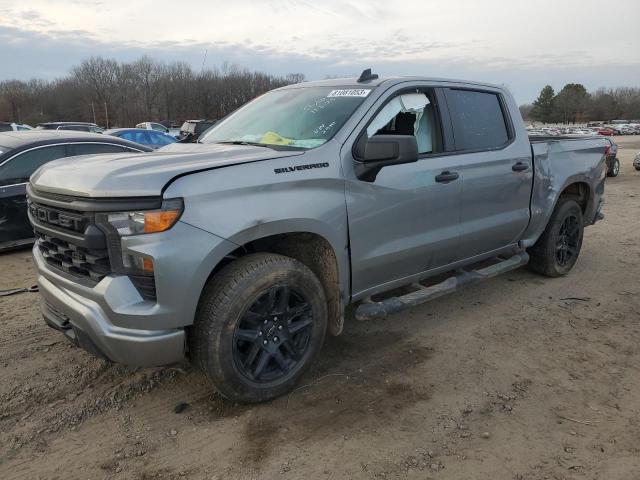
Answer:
[{"xmin": 28, "ymin": 71, "xmax": 606, "ymax": 402}]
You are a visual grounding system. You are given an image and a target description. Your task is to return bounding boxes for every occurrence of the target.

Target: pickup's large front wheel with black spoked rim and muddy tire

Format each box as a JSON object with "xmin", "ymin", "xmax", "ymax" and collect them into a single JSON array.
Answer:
[{"xmin": 189, "ymin": 253, "xmax": 327, "ymax": 403}]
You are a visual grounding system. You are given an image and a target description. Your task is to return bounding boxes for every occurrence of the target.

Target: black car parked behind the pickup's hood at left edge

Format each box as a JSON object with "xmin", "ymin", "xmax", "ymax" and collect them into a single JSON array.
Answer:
[{"xmin": 0, "ymin": 130, "xmax": 151, "ymax": 251}]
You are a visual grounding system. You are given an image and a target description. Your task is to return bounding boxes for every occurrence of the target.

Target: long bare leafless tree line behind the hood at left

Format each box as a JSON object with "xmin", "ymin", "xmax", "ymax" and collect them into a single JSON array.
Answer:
[{"xmin": 0, "ymin": 56, "xmax": 304, "ymax": 127}]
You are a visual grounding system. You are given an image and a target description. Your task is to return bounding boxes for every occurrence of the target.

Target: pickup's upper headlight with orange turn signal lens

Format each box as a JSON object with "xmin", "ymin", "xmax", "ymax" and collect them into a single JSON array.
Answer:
[{"xmin": 107, "ymin": 198, "xmax": 184, "ymax": 237}]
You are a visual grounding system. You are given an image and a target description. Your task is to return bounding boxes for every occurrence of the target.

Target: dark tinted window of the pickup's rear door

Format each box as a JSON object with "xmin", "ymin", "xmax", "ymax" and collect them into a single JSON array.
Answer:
[{"xmin": 446, "ymin": 89, "xmax": 509, "ymax": 150}]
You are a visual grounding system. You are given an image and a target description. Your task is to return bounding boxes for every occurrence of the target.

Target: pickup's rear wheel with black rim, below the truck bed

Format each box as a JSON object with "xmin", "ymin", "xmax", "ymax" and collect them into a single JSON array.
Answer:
[{"xmin": 529, "ymin": 198, "xmax": 584, "ymax": 277}]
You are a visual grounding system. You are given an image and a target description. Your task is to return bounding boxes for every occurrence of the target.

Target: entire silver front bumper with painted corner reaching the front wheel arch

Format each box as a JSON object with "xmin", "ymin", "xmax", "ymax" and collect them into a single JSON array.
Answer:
[{"xmin": 33, "ymin": 222, "xmax": 236, "ymax": 366}]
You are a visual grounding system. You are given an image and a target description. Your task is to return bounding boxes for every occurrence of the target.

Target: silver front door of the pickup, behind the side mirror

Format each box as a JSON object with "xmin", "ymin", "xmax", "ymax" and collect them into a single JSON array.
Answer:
[{"xmin": 344, "ymin": 87, "xmax": 462, "ymax": 297}]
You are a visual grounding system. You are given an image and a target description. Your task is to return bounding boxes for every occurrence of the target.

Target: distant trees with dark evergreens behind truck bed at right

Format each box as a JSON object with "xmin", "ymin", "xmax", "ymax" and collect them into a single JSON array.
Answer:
[{"xmin": 520, "ymin": 83, "xmax": 640, "ymax": 123}]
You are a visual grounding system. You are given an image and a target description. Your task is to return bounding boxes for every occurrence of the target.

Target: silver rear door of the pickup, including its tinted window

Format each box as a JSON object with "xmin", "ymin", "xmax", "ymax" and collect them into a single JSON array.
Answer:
[{"xmin": 444, "ymin": 88, "xmax": 533, "ymax": 259}]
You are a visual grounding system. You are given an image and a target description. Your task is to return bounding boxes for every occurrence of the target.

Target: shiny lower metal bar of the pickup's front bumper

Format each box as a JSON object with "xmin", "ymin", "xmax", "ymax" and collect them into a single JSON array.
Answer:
[{"xmin": 38, "ymin": 275, "xmax": 185, "ymax": 367}]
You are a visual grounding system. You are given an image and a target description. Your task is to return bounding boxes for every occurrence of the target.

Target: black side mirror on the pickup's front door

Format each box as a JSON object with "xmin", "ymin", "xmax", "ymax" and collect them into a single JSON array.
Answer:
[{"xmin": 355, "ymin": 135, "xmax": 418, "ymax": 182}]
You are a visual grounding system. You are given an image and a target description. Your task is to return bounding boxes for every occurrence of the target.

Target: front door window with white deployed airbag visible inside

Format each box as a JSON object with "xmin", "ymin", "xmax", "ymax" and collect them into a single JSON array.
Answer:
[{"xmin": 367, "ymin": 92, "xmax": 442, "ymax": 154}]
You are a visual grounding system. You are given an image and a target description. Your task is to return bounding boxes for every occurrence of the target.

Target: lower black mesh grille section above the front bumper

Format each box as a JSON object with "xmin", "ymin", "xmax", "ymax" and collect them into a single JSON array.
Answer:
[{"xmin": 36, "ymin": 230, "xmax": 111, "ymax": 283}]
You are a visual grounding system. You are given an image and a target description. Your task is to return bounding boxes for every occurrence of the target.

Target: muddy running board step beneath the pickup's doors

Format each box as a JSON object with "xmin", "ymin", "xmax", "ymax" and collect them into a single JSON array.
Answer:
[{"xmin": 356, "ymin": 251, "xmax": 529, "ymax": 320}]
